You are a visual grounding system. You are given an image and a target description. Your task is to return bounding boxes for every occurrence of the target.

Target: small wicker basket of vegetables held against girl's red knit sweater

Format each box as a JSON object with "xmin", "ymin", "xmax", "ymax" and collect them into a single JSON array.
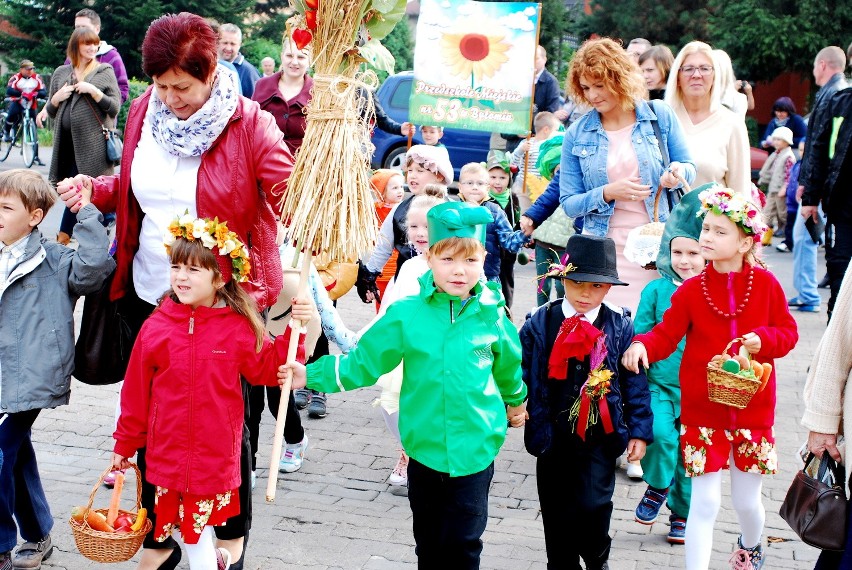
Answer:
[{"xmin": 707, "ymin": 337, "xmax": 772, "ymax": 409}]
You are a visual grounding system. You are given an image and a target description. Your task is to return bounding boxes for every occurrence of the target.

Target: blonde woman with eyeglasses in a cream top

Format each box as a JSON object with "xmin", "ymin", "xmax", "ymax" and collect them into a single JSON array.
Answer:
[{"xmin": 665, "ymin": 42, "xmax": 751, "ymax": 192}]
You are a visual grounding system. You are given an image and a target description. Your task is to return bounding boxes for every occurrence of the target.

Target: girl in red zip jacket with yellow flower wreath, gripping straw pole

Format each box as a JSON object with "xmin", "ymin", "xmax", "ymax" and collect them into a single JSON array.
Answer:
[{"xmin": 112, "ymin": 215, "xmax": 311, "ymax": 570}]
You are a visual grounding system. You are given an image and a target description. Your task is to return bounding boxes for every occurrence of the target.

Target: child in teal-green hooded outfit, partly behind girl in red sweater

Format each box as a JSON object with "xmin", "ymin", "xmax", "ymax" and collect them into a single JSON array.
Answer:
[{"xmin": 634, "ymin": 186, "xmax": 705, "ymax": 544}]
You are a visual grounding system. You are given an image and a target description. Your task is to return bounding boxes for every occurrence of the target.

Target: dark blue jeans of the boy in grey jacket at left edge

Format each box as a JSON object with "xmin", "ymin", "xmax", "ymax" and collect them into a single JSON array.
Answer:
[{"xmin": 0, "ymin": 410, "xmax": 53, "ymax": 552}]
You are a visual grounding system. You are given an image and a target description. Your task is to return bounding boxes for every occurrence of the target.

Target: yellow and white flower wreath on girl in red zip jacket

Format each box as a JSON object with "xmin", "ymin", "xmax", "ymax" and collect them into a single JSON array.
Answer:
[{"xmin": 163, "ymin": 212, "xmax": 251, "ymax": 283}]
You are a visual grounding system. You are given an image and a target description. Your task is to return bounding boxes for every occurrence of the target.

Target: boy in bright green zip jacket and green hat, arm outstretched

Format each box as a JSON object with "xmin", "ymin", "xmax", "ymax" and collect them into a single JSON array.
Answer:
[{"xmin": 286, "ymin": 202, "xmax": 527, "ymax": 569}]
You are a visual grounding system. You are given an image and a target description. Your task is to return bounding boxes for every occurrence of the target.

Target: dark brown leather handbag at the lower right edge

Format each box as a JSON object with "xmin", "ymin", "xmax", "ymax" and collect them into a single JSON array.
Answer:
[{"xmin": 779, "ymin": 453, "xmax": 847, "ymax": 551}]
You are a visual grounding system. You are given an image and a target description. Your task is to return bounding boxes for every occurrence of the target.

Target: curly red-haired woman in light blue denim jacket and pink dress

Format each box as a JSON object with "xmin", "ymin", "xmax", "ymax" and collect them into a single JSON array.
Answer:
[{"xmin": 559, "ymin": 38, "xmax": 695, "ymax": 312}]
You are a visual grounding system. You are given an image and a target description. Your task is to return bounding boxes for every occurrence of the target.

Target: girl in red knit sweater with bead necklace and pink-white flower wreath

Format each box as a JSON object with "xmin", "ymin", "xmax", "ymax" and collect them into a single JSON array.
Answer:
[{"xmin": 623, "ymin": 186, "xmax": 798, "ymax": 570}]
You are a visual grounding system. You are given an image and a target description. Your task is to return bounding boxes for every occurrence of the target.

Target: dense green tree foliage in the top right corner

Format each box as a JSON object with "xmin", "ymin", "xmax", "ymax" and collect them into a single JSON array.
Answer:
[{"xmin": 709, "ymin": 0, "xmax": 852, "ymax": 80}]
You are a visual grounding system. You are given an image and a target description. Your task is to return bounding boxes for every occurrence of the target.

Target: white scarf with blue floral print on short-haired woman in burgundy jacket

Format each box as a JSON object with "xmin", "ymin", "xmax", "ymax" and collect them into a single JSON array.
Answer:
[{"xmin": 148, "ymin": 67, "xmax": 240, "ymax": 158}]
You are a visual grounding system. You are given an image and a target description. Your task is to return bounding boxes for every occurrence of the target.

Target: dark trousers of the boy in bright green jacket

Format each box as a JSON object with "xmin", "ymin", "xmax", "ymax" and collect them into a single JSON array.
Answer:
[{"xmin": 408, "ymin": 458, "xmax": 494, "ymax": 570}]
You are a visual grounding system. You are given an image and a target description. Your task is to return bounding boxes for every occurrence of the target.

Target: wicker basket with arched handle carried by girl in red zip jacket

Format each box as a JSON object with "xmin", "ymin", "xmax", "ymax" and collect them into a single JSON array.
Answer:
[{"xmin": 68, "ymin": 463, "xmax": 151, "ymax": 563}]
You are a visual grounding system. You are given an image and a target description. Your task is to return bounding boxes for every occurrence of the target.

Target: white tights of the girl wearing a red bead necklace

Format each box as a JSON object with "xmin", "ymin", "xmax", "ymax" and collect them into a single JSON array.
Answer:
[{"xmin": 686, "ymin": 456, "xmax": 766, "ymax": 570}]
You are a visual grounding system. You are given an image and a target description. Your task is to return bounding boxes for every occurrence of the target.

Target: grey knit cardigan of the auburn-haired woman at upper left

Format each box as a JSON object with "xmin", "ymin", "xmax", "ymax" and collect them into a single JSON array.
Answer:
[{"xmin": 45, "ymin": 63, "xmax": 121, "ymax": 184}]
